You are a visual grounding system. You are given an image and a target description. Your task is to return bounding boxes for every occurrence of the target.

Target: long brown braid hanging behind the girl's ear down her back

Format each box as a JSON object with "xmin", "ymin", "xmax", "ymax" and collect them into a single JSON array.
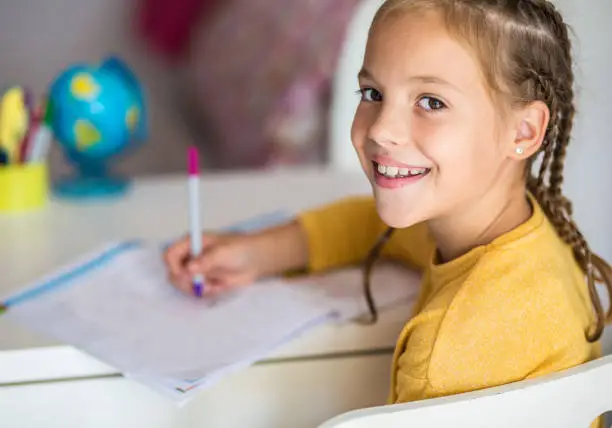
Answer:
[{"xmin": 525, "ymin": 0, "xmax": 612, "ymax": 341}]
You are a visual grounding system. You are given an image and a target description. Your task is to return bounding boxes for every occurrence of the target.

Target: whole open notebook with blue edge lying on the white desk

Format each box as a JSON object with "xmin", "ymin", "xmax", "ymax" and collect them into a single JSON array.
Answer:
[{"xmin": 4, "ymin": 213, "xmax": 414, "ymax": 404}]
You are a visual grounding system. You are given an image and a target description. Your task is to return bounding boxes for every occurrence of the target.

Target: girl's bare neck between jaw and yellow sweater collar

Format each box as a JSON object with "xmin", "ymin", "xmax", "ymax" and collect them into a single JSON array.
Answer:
[{"xmin": 429, "ymin": 186, "xmax": 532, "ymax": 263}]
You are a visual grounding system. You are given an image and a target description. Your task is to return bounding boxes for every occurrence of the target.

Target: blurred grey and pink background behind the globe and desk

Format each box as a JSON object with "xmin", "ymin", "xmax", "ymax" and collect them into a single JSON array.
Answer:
[{"xmin": 0, "ymin": 0, "xmax": 358, "ymax": 175}]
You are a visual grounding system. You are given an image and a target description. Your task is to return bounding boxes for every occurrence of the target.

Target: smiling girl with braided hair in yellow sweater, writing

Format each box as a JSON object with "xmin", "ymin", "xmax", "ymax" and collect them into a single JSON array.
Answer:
[{"xmin": 166, "ymin": 0, "xmax": 612, "ymax": 416}]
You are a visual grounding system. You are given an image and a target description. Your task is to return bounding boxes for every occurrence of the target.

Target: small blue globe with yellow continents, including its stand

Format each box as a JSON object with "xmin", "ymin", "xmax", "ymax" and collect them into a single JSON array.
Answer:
[{"xmin": 47, "ymin": 57, "xmax": 147, "ymax": 197}]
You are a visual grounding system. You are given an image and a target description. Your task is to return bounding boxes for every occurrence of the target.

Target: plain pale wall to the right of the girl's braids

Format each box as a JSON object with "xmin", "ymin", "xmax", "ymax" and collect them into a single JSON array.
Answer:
[{"xmin": 555, "ymin": 0, "xmax": 612, "ymax": 262}]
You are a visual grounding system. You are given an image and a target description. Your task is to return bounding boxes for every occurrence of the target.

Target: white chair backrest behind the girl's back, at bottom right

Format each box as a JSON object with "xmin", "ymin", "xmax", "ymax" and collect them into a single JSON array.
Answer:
[{"xmin": 319, "ymin": 355, "xmax": 612, "ymax": 428}]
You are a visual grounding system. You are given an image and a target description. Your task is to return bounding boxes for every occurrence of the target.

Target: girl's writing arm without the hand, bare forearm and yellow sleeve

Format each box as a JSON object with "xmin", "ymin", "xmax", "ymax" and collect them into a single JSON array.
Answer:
[{"xmin": 249, "ymin": 198, "xmax": 435, "ymax": 276}]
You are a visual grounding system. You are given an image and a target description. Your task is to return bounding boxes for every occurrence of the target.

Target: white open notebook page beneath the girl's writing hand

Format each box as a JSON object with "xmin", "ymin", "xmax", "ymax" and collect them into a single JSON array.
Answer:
[{"xmin": 2, "ymin": 242, "xmax": 326, "ymax": 378}]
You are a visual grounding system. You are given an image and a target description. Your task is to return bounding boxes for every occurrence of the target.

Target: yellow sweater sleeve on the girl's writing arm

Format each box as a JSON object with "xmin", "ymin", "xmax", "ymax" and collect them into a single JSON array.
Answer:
[{"xmin": 298, "ymin": 197, "xmax": 434, "ymax": 272}]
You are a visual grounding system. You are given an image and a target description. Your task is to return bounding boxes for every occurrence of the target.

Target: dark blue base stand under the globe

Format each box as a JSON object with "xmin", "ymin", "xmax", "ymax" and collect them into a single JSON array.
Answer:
[{"xmin": 53, "ymin": 161, "xmax": 131, "ymax": 200}]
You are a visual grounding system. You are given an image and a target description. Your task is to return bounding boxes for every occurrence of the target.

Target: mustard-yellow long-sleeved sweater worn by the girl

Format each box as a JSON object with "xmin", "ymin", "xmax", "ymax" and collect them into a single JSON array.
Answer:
[{"xmin": 299, "ymin": 198, "xmax": 600, "ymax": 403}]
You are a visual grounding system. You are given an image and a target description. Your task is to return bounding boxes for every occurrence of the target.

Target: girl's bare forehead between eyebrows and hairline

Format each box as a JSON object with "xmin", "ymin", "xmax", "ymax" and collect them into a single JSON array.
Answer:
[{"xmin": 364, "ymin": 11, "xmax": 484, "ymax": 89}]
